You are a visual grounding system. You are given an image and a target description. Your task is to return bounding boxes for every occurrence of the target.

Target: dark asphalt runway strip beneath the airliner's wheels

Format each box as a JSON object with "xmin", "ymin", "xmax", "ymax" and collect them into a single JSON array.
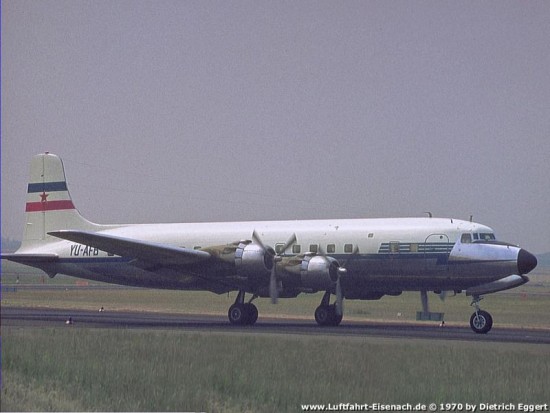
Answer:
[{"xmin": 1, "ymin": 307, "xmax": 550, "ymax": 344}]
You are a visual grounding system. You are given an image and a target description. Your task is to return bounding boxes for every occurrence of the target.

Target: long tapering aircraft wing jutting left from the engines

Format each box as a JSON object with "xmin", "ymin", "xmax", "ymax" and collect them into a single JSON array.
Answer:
[{"xmin": 48, "ymin": 230, "xmax": 211, "ymax": 267}]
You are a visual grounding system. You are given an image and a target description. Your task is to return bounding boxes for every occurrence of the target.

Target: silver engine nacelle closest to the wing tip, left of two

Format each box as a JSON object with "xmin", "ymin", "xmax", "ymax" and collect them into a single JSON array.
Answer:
[{"xmin": 235, "ymin": 242, "xmax": 275, "ymax": 277}]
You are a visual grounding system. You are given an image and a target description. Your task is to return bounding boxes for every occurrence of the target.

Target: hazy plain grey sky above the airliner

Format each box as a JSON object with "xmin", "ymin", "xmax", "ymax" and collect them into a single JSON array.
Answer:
[{"xmin": 2, "ymin": 0, "xmax": 550, "ymax": 253}]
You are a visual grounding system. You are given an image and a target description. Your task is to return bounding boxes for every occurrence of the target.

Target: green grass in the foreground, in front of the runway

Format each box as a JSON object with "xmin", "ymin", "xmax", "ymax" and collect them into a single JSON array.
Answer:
[{"xmin": 2, "ymin": 327, "xmax": 550, "ymax": 412}]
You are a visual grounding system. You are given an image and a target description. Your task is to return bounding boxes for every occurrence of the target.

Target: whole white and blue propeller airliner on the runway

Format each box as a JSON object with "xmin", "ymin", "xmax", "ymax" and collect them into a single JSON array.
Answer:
[{"xmin": 2, "ymin": 152, "xmax": 537, "ymax": 334}]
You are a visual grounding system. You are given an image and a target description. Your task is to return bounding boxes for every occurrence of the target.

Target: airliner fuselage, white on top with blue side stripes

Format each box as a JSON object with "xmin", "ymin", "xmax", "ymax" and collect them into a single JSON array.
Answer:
[{"xmin": 22, "ymin": 218, "xmax": 519, "ymax": 299}]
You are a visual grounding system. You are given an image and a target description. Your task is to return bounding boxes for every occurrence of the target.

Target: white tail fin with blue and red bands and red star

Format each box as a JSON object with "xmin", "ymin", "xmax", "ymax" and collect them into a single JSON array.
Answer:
[{"xmin": 22, "ymin": 152, "xmax": 102, "ymax": 248}]
